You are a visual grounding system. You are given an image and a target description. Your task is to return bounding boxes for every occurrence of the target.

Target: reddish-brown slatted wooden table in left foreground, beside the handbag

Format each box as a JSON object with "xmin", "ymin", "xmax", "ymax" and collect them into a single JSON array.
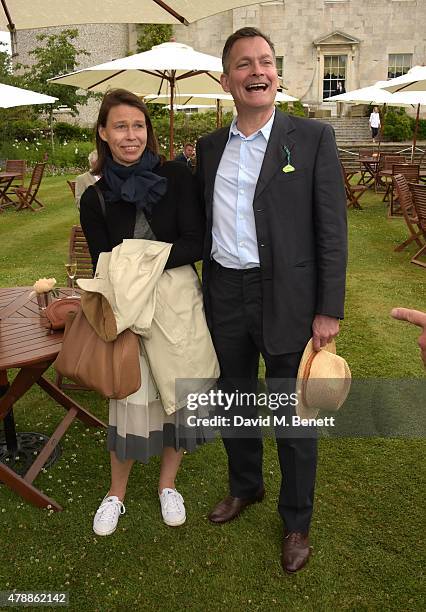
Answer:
[{"xmin": 0, "ymin": 287, "xmax": 105, "ymax": 510}]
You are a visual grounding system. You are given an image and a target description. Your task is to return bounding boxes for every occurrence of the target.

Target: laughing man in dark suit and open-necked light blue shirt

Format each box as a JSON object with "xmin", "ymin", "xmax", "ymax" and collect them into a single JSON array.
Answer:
[{"xmin": 197, "ymin": 28, "xmax": 346, "ymax": 572}]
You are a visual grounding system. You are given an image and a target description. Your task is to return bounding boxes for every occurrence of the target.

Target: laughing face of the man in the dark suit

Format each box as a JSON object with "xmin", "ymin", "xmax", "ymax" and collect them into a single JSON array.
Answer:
[{"xmin": 221, "ymin": 36, "xmax": 278, "ymax": 114}]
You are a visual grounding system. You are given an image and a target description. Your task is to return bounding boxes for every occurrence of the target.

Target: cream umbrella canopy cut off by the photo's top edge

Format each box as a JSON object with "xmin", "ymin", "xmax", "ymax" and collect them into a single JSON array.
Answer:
[{"xmin": 0, "ymin": 0, "xmax": 266, "ymax": 33}]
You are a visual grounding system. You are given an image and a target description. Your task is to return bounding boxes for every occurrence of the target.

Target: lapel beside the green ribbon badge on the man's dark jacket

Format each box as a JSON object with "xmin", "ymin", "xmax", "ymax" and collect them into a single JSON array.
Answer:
[{"xmin": 254, "ymin": 109, "xmax": 295, "ymax": 200}]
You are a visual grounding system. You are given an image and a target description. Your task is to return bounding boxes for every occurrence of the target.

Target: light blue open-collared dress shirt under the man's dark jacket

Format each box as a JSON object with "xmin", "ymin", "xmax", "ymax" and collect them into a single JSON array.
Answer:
[{"xmin": 211, "ymin": 110, "xmax": 275, "ymax": 270}]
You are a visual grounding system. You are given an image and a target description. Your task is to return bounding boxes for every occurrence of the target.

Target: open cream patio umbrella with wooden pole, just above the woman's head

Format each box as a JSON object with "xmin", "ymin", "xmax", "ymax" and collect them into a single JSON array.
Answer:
[{"xmin": 49, "ymin": 42, "xmax": 222, "ymax": 156}]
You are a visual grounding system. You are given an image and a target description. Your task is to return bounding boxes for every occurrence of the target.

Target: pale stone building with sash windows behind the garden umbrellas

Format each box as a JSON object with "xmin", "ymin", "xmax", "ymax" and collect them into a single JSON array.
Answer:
[{"xmin": 12, "ymin": 0, "xmax": 426, "ymax": 123}]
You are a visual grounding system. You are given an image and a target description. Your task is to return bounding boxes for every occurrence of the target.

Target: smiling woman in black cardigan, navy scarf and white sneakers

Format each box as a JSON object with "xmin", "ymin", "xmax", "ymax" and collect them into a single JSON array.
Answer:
[{"xmin": 80, "ymin": 89, "xmax": 204, "ymax": 535}]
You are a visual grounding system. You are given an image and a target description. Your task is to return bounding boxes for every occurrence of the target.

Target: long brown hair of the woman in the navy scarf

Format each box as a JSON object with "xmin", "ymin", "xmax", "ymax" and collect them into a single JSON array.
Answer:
[{"xmin": 93, "ymin": 89, "xmax": 158, "ymax": 174}]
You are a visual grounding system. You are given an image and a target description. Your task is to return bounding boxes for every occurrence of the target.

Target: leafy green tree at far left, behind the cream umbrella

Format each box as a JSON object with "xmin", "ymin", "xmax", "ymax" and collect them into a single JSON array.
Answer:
[{"xmin": 17, "ymin": 29, "xmax": 93, "ymax": 118}]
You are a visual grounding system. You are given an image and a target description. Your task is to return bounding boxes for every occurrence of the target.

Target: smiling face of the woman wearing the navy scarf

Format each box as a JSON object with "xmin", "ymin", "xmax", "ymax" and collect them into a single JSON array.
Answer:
[{"xmin": 99, "ymin": 104, "xmax": 147, "ymax": 166}]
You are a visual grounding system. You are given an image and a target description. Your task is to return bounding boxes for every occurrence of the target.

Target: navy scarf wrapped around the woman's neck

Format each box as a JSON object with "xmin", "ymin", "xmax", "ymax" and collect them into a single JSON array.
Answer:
[{"xmin": 103, "ymin": 149, "xmax": 167, "ymax": 214}]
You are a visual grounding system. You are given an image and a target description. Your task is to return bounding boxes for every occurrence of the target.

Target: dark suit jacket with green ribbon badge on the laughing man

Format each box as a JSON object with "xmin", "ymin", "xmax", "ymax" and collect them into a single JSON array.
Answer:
[{"xmin": 197, "ymin": 110, "xmax": 347, "ymax": 355}]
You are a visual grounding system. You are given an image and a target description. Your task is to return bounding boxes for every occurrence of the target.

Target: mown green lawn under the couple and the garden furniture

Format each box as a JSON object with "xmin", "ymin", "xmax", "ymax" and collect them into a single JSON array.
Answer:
[{"xmin": 0, "ymin": 176, "xmax": 426, "ymax": 612}]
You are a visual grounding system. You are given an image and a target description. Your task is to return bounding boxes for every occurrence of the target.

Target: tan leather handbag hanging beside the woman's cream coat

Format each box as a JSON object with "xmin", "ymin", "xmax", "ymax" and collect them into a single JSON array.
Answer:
[{"xmin": 53, "ymin": 308, "xmax": 141, "ymax": 399}]
